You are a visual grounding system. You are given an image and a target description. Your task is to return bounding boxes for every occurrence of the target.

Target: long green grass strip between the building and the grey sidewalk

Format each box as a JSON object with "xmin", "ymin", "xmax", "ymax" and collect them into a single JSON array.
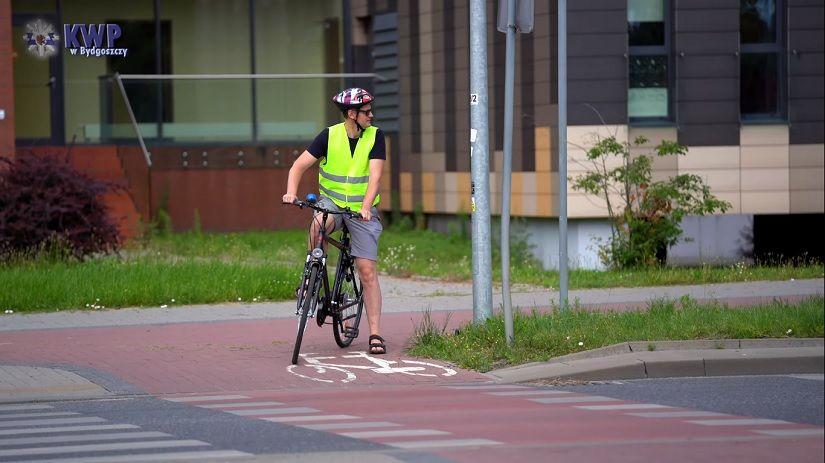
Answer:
[{"xmin": 0, "ymin": 229, "xmax": 825, "ymax": 312}]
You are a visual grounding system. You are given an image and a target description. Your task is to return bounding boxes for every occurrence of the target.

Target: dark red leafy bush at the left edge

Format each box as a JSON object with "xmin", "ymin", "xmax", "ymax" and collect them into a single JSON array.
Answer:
[{"xmin": 0, "ymin": 152, "xmax": 121, "ymax": 260}]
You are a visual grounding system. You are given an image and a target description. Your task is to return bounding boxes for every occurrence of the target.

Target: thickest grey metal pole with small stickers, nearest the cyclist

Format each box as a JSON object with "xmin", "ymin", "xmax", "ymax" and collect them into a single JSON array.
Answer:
[{"xmin": 469, "ymin": 0, "xmax": 493, "ymax": 322}]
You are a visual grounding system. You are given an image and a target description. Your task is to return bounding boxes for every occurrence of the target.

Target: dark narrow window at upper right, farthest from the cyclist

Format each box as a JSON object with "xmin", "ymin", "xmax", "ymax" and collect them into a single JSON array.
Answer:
[{"xmin": 739, "ymin": 0, "xmax": 785, "ymax": 120}]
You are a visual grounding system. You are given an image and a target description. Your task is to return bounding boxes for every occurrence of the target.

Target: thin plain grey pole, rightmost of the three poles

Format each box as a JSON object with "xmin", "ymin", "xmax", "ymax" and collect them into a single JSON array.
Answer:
[{"xmin": 558, "ymin": 0, "xmax": 567, "ymax": 310}]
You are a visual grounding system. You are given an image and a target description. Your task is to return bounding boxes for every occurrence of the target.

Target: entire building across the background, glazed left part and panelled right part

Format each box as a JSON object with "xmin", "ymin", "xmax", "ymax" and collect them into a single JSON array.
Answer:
[{"xmin": 0, "ymin": 0, "xmax": 825, "ymax": 267}]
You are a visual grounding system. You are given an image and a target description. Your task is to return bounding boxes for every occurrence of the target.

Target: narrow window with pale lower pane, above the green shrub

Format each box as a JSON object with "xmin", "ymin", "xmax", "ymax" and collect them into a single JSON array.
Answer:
[{"xmin": 627, "ymin": 0, "xmax": 671, "ymax": 121}]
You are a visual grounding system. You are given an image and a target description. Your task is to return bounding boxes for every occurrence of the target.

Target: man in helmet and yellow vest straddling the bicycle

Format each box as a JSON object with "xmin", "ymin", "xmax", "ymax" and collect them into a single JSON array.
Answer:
[{"xmin": 283, "ymin": 88, "xmax": 387, "ymax": 355}]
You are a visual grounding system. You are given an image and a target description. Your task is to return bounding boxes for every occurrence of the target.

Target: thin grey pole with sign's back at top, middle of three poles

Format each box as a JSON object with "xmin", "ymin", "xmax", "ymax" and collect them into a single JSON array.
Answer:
[{"xmin": 501, "ymin": 0, "xmax": 516, "ymax": 345}]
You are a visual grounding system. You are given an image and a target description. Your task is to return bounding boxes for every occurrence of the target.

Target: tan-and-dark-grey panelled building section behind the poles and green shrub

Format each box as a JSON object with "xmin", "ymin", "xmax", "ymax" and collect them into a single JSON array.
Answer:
[{"xmin": 384, "ymin": 0, "xmax": 825, "ymax": 267}]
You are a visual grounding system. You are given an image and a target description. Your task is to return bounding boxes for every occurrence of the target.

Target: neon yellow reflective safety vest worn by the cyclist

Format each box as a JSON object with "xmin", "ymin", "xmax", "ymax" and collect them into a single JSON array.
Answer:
[{"xmin": 318, "ymin": 122, "xmax": 381, "ymax": 212}]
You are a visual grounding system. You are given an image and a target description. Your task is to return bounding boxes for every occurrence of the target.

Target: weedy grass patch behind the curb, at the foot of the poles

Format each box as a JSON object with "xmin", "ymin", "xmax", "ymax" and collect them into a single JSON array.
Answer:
[{"xmin": 409, "ymin": 297, "xmax": 825, "ymax": 372}]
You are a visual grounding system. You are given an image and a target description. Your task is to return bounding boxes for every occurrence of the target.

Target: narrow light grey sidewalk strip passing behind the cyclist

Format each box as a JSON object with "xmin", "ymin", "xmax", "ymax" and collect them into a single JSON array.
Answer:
[{"xmin": 0, "ymin": 277, "xmax": 825, "ymax": 332}]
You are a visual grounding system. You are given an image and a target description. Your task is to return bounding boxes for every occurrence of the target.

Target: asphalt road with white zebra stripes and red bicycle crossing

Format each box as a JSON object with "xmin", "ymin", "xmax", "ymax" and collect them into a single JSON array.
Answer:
[{"xmin": 0, "ymin": 375, "xmax": 823, "ymax": 463}]
